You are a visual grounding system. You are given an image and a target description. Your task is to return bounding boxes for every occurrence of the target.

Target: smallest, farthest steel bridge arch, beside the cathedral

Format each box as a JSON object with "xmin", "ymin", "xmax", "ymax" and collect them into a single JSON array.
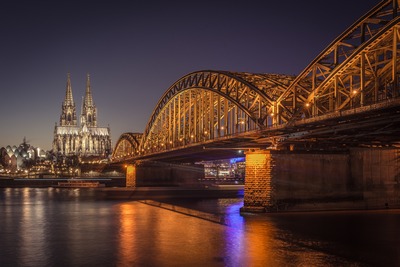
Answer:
[{"xmin": 112, "ymin": 133, "xmax": 143, "ymax": 160}]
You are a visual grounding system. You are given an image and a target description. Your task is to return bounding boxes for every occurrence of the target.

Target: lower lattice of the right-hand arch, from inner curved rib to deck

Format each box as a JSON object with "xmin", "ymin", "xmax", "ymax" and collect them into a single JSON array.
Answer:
[{"xmin": 303, "ymin": 21, "xmax": 400, "ymax": 116}]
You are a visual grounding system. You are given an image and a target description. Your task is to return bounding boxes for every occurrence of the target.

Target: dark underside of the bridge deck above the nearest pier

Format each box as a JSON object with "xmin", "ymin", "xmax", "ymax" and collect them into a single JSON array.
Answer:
[{"xmin": 256, "ymin": 99, "xmax": 400, "ymax": 150}]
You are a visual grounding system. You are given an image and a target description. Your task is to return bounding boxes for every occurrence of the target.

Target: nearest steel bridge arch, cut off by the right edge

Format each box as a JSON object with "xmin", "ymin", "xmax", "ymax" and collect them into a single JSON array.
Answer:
[{"xmin": 276, "ymin": 0, "xmax": 399, "ymax": 124}]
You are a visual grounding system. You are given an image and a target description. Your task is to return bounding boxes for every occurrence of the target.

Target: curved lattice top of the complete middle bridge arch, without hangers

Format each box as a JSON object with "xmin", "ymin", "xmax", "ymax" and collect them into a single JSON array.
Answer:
[{"xmin": 141, "ymin": 71, "xmax": 294, "ymax": 155}]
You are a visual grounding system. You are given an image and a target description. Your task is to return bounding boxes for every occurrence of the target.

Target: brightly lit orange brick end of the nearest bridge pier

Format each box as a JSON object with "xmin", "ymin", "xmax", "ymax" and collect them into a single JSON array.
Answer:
[{"xmin": 240, "ymin": 150, "xmax": 275, "ymax": 212}]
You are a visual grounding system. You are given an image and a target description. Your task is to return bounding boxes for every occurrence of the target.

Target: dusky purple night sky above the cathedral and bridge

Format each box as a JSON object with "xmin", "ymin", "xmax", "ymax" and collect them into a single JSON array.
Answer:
[{"xmin": 0, "ymin": 0, "xmax": 379, "ymax": 149}]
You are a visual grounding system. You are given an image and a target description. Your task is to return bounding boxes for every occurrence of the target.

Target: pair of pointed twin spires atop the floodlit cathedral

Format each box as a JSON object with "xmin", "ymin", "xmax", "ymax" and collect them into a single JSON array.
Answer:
[{"xmin": 60, "ymin": 73, "xmax": 97, "ymax": 127}]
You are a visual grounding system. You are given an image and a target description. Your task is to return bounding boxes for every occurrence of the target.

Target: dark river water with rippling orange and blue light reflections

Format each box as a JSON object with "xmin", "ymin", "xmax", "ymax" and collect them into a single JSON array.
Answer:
[{"xmin": 0, "ymin": 188, "xmax": 400, "ymax": 266}]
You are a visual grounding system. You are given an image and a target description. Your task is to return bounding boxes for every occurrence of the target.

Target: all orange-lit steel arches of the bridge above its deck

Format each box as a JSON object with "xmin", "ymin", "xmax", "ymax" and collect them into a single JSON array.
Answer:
[{"xmin": 113, "ymin": 0, "xmax": 400, "ymax": 161}]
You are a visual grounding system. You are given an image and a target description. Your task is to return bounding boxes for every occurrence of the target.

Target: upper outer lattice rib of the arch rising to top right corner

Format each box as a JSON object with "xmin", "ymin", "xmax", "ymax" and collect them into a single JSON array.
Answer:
[{"xmin": 278, "ymin": 0, "xmax": 399, "ymax": 122}]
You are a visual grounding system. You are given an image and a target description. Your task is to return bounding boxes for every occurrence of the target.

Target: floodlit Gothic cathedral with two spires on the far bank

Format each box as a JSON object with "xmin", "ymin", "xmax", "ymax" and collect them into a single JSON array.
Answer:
[{"xmin": 53, "ymin": 74, "xmax": 112, "ymax": 157}]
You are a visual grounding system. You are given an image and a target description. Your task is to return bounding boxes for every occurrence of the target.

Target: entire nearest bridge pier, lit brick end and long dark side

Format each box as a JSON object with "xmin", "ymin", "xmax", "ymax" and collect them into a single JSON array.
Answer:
[{"xmin": 241, "ymin": 148, "xmax": 400, "ymax": 212}]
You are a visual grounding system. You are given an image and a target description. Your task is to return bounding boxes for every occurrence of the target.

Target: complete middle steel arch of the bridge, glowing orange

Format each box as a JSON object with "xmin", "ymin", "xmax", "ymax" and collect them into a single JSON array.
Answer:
[{"xmin": 140, "ymin": 70, "xmax": 294, "ymax": 154}]
